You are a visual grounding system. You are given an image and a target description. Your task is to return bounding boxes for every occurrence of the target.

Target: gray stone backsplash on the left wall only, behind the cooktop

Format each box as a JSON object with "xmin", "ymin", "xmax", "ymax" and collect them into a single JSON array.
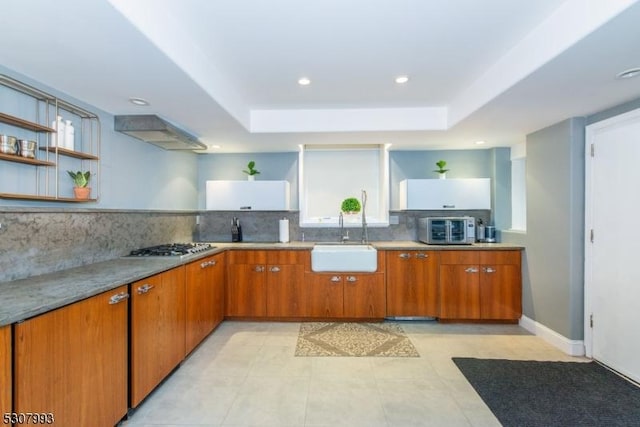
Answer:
[{"xmin": 0, "ymin": 210, "xmax": 196, "ymax": 283}]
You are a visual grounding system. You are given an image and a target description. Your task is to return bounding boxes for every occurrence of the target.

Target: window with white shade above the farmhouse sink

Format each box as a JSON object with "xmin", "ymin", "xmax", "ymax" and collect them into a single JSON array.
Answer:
[{"xmin": 298, "ymin": 145, "xmax": 389, "ymax": 227}]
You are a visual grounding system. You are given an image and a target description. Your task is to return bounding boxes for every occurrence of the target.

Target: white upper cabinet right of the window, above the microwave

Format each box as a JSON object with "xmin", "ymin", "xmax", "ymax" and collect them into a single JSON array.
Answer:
[{"xmin": 399, "ymin": 178, "xmax": 491, "ymax": 210}]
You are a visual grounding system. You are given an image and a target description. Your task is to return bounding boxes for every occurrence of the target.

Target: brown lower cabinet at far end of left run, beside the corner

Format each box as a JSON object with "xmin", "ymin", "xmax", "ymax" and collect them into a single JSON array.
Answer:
[{"xmin": 185, "ymin": 253, "xmax": 226, "ymax": 353}]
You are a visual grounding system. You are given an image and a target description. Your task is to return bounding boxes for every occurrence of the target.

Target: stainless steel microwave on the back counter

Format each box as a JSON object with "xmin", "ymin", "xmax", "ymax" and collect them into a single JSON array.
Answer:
[{"xmin": 418, "ymin": 216, "xmax": 476, "ymax": 245}]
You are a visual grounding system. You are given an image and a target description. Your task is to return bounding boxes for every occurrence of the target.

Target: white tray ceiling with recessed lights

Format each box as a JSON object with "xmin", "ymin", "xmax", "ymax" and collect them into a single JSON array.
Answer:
[{"xmin": 0, "ymin": 0, "xmax": 640, "ymax": 152}]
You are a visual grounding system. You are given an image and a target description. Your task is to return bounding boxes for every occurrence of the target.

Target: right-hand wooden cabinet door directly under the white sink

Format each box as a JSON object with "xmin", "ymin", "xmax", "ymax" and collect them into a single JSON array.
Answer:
[{"xmin": 343, "ymin": 273, "xmax": 386, "ymax": 319}]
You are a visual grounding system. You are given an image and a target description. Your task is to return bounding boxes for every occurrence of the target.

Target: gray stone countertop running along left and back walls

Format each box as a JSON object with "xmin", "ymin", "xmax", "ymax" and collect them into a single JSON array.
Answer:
[{"xmin": 0, "ymin": 241, "xmax": 523, "ymax": 326}]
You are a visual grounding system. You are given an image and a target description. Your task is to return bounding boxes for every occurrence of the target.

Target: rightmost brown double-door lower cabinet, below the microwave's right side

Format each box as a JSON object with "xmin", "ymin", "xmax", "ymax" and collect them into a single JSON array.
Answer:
[{"xmin": 440, "ymin": 250, "xmax": 522, "ymax": 322}]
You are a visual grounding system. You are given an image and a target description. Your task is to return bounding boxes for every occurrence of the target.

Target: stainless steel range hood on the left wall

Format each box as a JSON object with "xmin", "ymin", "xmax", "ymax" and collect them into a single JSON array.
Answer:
[{"xmin": 114, "ymin": 115, "xmax": 207, "ymax": 150}]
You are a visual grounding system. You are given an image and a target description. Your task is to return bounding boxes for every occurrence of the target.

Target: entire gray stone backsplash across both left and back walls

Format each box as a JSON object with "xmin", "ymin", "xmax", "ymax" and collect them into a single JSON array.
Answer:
[{"xmin": 0, "ymin": 209, "xmax": 490, "ymax": 283}]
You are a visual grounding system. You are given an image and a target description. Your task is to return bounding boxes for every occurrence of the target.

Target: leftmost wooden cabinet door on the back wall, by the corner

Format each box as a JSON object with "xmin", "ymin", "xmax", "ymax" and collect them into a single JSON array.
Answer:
[{"xmin": 225, "ymin": 264, "xmax": 267, "ymax": 317}]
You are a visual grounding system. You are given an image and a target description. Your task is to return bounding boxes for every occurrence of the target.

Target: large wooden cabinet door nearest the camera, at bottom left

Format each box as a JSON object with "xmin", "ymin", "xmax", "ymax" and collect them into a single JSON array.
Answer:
[{"xmin": 13, "ymin": 286, "xmax": 128, "ymax": 427}]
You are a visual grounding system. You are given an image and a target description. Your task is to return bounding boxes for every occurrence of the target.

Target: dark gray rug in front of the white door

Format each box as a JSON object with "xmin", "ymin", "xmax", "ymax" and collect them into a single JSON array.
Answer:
[{"xmin": 453, "ymin": 357, "xmax": 640, "ymax": 427}]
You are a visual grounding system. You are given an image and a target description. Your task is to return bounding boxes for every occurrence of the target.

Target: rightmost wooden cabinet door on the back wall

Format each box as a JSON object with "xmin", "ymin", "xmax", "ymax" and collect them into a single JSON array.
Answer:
[{"xmin": 480, "ymin": 264, "xmax": 522, "ymax": 320}]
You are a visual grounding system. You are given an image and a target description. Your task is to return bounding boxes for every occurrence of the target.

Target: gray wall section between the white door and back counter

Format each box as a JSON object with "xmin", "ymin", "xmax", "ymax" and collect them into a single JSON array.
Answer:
[{"xmin": 503, "ymin": 118, "xmax": 585, "ymax": 340}]
